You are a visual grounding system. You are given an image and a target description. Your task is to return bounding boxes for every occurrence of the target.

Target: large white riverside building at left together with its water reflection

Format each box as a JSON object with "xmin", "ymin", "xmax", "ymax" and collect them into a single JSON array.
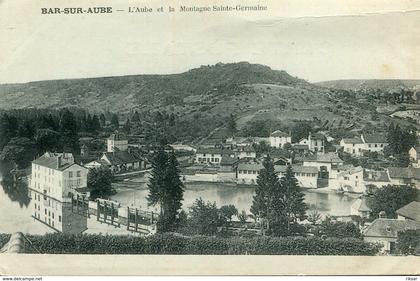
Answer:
[{"xmin": 29, "ymin": 152, "xmax": 89, "ymax": 233}]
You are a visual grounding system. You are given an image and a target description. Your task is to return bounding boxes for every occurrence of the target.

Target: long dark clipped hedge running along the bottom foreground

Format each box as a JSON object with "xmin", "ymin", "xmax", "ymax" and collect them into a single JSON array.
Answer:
[{"xmin": 0, "ymin": 233, "xmax": 379, "ymax": 256}]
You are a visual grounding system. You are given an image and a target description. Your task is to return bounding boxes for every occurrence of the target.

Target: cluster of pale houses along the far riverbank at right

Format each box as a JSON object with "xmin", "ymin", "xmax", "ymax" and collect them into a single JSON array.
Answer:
[{"xmin": 188, "ymin": 131, "xmax": 420, "ymax": 193}]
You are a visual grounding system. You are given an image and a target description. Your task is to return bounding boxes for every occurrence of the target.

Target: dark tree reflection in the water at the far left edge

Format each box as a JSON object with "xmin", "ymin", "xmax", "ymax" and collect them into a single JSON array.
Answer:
[{"xmin": 0, "ymin": 161, "xmax": 31, "ymax": 207}]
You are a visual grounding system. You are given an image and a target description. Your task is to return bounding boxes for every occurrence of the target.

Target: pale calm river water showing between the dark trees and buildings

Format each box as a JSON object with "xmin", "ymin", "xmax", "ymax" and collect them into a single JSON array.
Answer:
[{"xmin": 0, "ymin": 162, "xmax": 356, "ymax": 234}]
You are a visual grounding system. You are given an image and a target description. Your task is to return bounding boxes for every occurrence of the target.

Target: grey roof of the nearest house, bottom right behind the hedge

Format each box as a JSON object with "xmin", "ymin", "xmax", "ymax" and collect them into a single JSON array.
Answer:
[{"xmin": 363, "ymin": 218, "xmax": 420, "ymax": 238}]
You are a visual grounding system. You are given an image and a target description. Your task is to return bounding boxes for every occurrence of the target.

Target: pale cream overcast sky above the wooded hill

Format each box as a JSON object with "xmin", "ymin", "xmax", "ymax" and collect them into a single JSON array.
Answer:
[{"xmin": 0, "ymin": 0, "xmax": 420, "ymax": 83}]
